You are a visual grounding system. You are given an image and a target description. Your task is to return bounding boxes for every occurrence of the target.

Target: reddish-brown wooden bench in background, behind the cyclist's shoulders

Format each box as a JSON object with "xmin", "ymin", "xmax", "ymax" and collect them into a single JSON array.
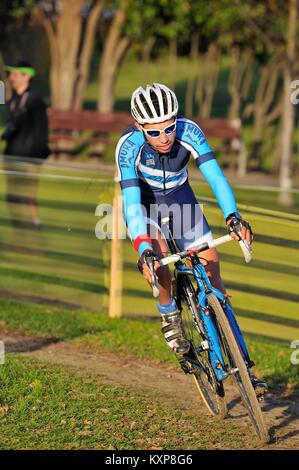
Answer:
[{"xmin": 48, "ymin": 108, "xmax": 246, "ymax": 175}]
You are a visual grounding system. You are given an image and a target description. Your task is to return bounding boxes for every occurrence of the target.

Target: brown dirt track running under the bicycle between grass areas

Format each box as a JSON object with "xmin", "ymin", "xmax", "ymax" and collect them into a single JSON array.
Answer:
[{"xmin": 1, "ymin": 333, "xmax": 299, "ymax": 450}]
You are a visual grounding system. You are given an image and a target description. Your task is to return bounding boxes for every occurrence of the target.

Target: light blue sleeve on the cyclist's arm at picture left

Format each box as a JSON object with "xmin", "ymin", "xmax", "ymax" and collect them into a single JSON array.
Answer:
[{"xmin": 115, "ymin": 128, "xmax": 152, "ymax": 255}]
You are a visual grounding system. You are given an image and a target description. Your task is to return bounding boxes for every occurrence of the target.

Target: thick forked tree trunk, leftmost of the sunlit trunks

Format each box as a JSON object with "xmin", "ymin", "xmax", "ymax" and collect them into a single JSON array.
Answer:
[{"xmin": 40, "ymin": 0, "xmax": 102, "ymax": 110}]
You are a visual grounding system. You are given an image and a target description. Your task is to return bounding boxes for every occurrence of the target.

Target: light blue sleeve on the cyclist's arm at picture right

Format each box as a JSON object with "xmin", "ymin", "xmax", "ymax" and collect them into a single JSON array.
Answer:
[{"xmin": 178, "ymin": 118, "xmax": 237, "ymax": 219}]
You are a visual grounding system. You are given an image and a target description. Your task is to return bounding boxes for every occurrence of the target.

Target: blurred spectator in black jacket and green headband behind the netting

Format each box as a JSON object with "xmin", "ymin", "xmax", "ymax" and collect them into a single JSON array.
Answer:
[{"xmin": 2, "ymin": 60, "xmax": 50, "ymax": 227}]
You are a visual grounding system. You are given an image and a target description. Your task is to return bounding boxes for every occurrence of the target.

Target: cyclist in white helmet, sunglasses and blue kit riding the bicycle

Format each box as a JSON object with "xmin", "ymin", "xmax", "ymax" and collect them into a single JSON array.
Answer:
[{"xmin": 116, "ymin": 83, "xmax": 267, "ymax": 394}]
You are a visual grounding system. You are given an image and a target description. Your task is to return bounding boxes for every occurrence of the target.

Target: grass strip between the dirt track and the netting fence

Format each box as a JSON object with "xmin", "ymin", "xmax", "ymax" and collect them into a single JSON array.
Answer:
[{"xmin": 0, "ymin": 300, "xmax": 299, "ymax": 393}]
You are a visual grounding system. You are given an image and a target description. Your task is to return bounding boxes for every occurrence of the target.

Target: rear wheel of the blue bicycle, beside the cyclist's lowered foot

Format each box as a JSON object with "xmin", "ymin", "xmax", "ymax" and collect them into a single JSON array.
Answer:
[{"xmin": 179, "ymin": 276, "xmax": 227, "ymax": 419}]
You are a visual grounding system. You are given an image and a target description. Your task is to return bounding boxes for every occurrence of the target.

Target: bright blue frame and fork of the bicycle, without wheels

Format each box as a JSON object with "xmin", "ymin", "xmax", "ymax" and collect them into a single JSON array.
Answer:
[{"xmin": 176, "ymin": 263, "xmax": 251, "ymax": 382}]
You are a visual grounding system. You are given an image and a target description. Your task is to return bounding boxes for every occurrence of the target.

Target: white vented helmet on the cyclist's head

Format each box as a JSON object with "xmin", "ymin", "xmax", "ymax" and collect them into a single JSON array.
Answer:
[{"xmin": 131, "ymin": 83, "xmax": 179, "ymax": 124}]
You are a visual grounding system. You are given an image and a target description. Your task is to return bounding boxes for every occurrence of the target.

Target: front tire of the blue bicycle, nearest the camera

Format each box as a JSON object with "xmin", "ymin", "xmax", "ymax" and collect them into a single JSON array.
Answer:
[{"xmin": 208, "ymin": 295, "xmax": 270, "ymax": 443}]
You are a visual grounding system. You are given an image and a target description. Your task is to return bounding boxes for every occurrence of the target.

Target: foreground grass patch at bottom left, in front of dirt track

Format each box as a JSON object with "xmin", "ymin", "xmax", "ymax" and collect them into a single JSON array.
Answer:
[{"xmin": 0, "ymin": 355, "xmax": 255, "ymax": 450}]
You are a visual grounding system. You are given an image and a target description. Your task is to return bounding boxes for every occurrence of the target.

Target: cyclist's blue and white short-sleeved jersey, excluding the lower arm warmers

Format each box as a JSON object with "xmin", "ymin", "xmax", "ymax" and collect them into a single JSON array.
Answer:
[{"xmin": 116, "ymin": 118, "xmax": 215, "ymax": 194}]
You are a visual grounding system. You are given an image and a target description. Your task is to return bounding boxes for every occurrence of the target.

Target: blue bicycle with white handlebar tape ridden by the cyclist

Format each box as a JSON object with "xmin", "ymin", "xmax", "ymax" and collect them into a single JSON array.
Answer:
[{"xmin": 150, "ymin": 218, "xmax": 269, "ymax": 443}]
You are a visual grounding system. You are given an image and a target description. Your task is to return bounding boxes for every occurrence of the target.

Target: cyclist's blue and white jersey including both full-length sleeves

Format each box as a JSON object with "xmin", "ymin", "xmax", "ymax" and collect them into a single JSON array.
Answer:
[{"xmin": 116, "ymin": 117, "xmax": 237, "ymax": 249}]
